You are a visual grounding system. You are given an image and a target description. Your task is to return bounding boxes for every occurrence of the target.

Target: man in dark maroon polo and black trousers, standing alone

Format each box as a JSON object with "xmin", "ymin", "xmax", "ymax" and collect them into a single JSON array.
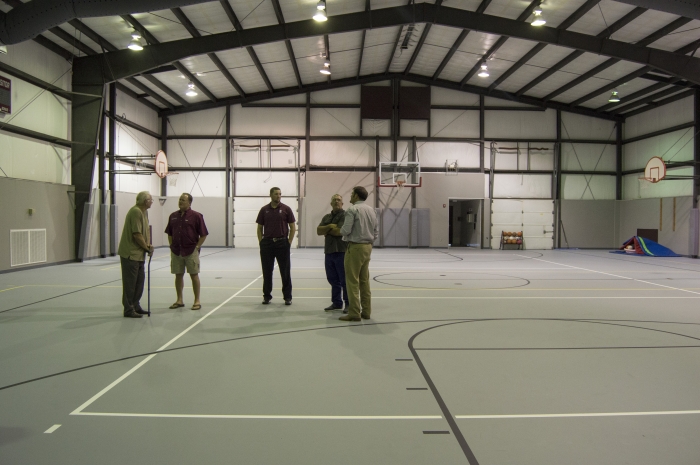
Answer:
[{"xmin": 255, "ymin": 187, "xmax": 296, "ymax": 305}]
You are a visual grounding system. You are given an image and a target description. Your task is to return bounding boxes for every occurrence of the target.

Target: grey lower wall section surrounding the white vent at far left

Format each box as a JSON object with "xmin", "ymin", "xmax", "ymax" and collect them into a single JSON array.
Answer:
[{"xmin": 0, "ymin": 178, "xmax": 75, "ymax": 271}]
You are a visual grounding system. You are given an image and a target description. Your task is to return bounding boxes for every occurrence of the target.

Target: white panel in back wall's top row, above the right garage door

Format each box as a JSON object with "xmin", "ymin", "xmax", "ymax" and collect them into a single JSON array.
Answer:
[{"xmin": 485, "ymin": 110, "xmax": 557, "ymax": 139}]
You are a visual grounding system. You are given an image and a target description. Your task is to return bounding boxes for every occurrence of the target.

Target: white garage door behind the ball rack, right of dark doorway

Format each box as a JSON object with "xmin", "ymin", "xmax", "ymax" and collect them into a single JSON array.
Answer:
[{"xmin": 491, "ymin": 199, "xmax": 554, "ymax": 250}]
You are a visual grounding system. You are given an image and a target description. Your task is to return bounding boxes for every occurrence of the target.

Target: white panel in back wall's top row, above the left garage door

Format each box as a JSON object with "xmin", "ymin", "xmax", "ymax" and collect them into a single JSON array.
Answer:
[{"xmin": 231, "ymin": 105, "xmax": 306, "ymax": 136}]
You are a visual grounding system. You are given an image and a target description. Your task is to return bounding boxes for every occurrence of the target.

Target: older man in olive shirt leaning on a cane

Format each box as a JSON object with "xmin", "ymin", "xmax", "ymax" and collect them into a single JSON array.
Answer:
[{"xmin": 117, "ymin": 191, "xmax": 153, "ymax": 318}]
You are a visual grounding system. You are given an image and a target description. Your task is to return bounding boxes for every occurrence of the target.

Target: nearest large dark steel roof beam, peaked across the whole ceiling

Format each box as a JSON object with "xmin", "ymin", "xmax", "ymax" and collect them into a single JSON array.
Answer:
[{"xmin": 74, "ymin": 3, "xmax": 700, "ymax": 87}]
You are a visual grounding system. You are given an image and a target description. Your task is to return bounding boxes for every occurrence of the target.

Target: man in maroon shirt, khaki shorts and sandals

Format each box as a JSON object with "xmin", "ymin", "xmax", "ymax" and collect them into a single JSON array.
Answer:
[{"xmin": 165, "ymin": 193, "xmax": 209, "ymax": 310}]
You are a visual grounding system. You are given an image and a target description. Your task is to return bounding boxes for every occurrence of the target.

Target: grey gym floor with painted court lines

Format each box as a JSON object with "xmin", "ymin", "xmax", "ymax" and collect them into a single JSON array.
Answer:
[{"xmin": 0, "ymin": 248, "xmax": 700, "ymax": 465}]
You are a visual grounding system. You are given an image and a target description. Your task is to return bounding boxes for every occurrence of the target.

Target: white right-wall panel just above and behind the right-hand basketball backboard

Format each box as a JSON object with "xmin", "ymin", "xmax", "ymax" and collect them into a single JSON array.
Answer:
[{"xmin": 622, "ymin": 128, "xmax": 694, "ymax": 170}]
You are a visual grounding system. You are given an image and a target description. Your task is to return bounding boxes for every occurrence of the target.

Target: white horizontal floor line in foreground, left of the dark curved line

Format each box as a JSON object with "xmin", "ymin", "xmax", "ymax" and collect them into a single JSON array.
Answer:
[{"xmin": 71, "ymin": 412, "xmax": 442, "ymax": 420}]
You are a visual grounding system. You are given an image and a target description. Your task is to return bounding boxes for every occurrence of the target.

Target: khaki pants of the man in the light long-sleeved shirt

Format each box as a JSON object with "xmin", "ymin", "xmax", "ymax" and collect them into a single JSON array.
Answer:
[{"xmin": 345, "ymin": 242, "xmax": 372, "ymax": 318}]
